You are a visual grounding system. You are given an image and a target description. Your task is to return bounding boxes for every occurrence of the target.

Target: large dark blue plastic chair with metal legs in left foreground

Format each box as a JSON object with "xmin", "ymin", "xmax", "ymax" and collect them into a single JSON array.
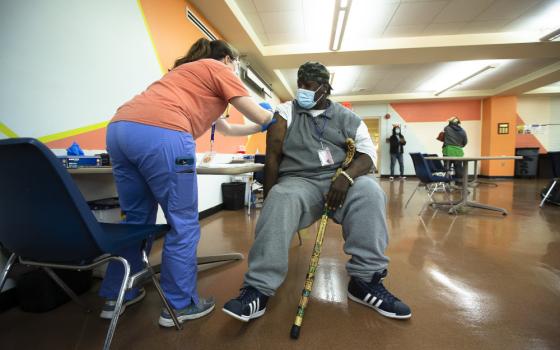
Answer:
[{"xmin": 0, "ymin": 138, "xmax": 181, "ymax": 349}]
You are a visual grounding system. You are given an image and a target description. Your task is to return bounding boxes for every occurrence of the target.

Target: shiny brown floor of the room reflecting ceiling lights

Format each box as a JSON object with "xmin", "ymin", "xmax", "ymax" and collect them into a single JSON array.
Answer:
[{"xmin": 0, "ymin": 180, "xmax": 560, "ymax": 350}]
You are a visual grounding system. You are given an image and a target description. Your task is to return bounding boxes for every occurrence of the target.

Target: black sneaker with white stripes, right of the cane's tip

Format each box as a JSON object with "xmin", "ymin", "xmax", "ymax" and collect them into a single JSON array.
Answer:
[{"xmin": 348, "ymin": 270, "xmax": 412, "ymax": 319}]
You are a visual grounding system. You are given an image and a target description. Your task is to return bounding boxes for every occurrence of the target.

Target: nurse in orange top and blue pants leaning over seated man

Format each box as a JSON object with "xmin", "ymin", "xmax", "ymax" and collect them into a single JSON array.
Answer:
[{"xmin": 99, "ymin": 39, "xmax": 272, "ymax": 327}]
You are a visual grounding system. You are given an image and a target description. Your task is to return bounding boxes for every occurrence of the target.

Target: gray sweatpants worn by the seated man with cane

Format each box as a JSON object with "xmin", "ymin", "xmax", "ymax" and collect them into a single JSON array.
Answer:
[{"xmin": 244, "ymin": 176, "xmax": 389, "ymax": 296}]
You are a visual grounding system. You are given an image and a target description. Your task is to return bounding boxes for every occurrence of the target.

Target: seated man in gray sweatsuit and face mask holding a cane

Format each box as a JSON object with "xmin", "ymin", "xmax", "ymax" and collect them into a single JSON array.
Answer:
[{"xmin": 223, "ymin": 62, "xmax": 412, "ymax": 322}]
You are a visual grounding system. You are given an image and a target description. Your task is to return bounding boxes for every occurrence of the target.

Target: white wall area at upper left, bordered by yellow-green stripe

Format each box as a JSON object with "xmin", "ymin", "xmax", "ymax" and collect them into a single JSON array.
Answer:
[{"xmin": 0, "ymin": 0, "xmax": 161, "ymax": 137}]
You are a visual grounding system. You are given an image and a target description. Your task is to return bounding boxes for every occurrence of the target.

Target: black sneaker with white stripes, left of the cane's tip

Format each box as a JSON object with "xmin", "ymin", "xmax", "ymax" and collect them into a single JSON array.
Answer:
[{"xmin": 222, "ymin": 286, "xmax": 268, "ymax": 322}]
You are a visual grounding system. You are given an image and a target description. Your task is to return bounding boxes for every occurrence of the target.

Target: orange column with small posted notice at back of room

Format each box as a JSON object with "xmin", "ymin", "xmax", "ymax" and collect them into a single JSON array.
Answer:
[{"xmin": 480, "ymin": 96, "xmax": 517, "ymax": 176}]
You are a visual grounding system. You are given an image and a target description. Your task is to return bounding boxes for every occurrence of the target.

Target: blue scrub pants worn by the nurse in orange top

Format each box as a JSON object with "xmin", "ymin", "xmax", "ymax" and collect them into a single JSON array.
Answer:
[{"xmin": 99, "ymin": 121, "xmax": 200, "ymax": 309}]
